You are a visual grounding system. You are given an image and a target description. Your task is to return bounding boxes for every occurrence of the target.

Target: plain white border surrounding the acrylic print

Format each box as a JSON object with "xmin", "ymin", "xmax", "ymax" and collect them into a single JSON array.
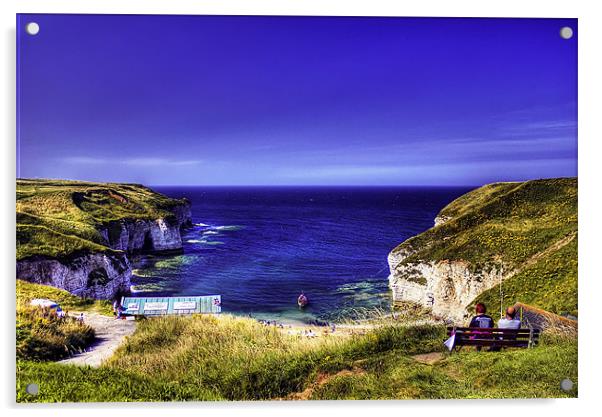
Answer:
[{"xmin": 0, "ymin": 0, "xmax": 602, "ymax": 417}]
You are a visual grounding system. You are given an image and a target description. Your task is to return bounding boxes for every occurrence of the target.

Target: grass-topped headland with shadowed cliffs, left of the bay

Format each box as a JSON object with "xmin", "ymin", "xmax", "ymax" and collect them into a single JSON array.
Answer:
[{"xmin": 16, "ymin": 179, "xmax": 191, "ymax": 299}]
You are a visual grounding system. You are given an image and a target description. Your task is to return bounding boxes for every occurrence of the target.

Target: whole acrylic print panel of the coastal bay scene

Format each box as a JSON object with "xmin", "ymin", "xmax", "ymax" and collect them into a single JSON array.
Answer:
[{"xmin": 16, "ymin": 14, "xmax": 578, "ymax": 402}]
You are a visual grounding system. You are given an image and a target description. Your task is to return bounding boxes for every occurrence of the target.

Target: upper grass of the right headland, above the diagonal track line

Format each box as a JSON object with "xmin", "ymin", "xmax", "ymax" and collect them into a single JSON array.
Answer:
[{"xmin": 398, "ymin": 178, "xmax": 577, "ymax": 267}]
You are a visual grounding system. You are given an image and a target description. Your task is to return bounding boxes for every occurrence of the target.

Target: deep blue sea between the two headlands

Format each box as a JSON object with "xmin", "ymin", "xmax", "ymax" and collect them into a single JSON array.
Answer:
[{"xmin": 133, "ymin": 187, "xmax": 470, "ymax": 323}]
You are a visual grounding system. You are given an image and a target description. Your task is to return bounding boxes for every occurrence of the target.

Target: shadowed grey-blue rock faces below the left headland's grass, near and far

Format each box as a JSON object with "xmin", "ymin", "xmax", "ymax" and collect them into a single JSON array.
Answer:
[{"xmin": 17, "ymin": 201, "xmax": 192, "ymax": 299}]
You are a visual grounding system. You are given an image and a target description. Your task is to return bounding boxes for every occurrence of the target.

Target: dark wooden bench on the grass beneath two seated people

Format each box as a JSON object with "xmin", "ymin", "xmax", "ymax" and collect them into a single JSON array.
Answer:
[{"xmin": 447, "ymin": 327, "xmax": 539, "ymax": 350}]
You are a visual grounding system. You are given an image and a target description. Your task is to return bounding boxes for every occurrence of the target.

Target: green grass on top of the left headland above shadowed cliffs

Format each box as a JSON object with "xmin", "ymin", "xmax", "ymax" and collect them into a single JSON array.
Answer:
[{"xmin": 16, "ymin": 179, "xmax": 188, "ymax": 260}]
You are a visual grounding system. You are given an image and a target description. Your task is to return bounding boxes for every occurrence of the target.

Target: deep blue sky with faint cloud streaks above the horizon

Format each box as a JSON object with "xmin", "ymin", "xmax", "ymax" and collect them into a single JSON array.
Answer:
[{"xmin": 17, "ymin": 15, "xmax": 577, "ymax": 185}]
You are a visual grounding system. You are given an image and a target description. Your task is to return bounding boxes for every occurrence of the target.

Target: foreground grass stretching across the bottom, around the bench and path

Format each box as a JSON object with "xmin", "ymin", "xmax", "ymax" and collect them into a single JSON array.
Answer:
[{"xmin": 17, "ymin": 316, "xmax": 577, "ymax": 402}]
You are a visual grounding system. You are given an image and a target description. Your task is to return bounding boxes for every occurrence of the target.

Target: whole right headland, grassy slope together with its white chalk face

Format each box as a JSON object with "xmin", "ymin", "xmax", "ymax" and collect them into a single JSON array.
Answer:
[{"xmin": 389, "ymin": 178, "xmax": 577, "ymax": 321}]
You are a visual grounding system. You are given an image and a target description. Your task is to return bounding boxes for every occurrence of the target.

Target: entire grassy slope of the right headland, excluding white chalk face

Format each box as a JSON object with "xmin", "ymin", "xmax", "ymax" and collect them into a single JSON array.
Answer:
[{"xmin": 394, "ymin": 178, "xmax": 577, "ymax": 314}]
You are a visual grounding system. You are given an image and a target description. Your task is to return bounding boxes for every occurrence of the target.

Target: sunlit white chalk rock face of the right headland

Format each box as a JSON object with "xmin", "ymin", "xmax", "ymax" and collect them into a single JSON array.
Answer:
[{"xmin": 388, "ymin": 250, "xmax": 502, "ymax": 324}]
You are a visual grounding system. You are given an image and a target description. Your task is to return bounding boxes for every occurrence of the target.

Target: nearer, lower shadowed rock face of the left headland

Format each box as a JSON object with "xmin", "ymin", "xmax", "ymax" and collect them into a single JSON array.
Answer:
[{"xmin": 17, "ymin": 252, "xmax": 132, "ymax": 299}]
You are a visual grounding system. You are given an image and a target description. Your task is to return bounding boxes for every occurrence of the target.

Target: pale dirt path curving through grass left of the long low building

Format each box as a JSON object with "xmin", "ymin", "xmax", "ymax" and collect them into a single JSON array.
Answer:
[{"xmin": 59, "ymin": 313, "xmax": 136, "ymax": 368}]
